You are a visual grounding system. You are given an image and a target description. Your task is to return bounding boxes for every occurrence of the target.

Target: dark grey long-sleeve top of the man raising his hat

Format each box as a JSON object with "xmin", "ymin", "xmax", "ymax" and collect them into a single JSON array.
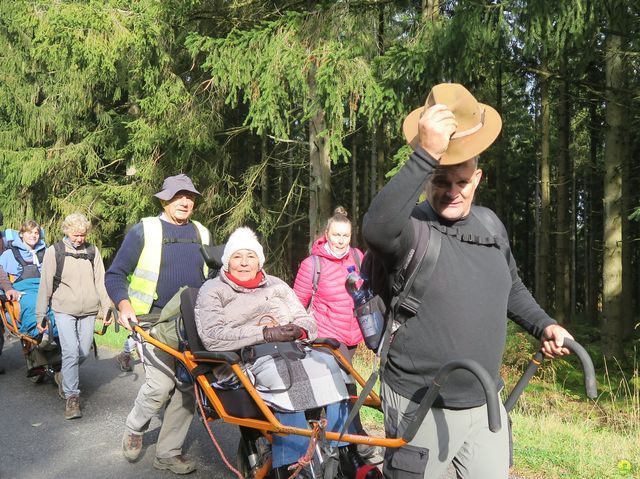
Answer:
[{"xmin": 363, "ymin": 149, "xmax": 554, "ymax": 408}]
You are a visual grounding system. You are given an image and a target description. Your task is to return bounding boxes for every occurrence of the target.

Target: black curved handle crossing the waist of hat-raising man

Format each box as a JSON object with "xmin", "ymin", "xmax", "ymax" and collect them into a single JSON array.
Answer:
[{"xmin": 402, "ymin": 359, "xmax": 502, "ymax": 442}]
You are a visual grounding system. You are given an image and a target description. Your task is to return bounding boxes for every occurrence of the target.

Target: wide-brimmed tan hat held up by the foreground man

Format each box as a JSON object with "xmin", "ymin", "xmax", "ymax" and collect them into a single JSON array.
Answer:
[{"xmin": 402, "ymin": 83, "xmax": 502, "ymax": 165}]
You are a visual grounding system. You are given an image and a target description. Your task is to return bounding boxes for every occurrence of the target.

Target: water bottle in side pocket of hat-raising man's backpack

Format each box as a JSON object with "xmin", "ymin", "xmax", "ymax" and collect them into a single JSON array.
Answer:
[{"xmin": 345, "ymin": 266, "xmax": 384, "ymax": 351}]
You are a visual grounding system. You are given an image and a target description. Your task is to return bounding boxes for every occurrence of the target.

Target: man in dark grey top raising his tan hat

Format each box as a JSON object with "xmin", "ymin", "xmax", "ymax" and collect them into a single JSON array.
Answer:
[{"xmin": 363, "ymin": 83, "xmax": 571, "ymax": 479}]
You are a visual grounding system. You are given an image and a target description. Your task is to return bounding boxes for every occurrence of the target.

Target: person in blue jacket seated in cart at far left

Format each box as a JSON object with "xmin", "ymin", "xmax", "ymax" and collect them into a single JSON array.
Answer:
[{"xmin": 0, "ymin": 220, "xmax": 58, "ymax": 337}]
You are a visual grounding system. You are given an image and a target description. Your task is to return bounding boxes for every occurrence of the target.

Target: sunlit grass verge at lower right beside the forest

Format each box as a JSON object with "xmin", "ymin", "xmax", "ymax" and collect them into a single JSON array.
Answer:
[{"xmin": 354, "ymin": 331, "xmax": 640, "ymax": 479}]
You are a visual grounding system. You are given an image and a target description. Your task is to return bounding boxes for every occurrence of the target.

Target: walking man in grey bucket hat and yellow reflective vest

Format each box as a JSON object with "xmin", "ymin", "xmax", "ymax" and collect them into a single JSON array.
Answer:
[{"xmin": 105, "ymin": 174, "xmax": 211, "ymax": 474}]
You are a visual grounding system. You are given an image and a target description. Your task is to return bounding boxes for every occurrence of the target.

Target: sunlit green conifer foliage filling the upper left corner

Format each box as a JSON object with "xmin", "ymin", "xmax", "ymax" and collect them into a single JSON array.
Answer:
[{"xmin": 0, "ymin": 0, "xmax": 224, "ymax": 254}]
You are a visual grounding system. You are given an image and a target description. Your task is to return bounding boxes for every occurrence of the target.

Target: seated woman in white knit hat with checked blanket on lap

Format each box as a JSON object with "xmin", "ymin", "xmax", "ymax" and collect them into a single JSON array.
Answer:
[{"xmin": 195, "ymin": 228, "xmax": 377, "ymax": 478}]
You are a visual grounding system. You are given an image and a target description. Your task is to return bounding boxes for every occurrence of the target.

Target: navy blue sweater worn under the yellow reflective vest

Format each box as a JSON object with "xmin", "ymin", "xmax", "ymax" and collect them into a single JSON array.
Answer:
[{"xmin": 105, "ymin": 220, "xmax": 205, "ymax": 308}]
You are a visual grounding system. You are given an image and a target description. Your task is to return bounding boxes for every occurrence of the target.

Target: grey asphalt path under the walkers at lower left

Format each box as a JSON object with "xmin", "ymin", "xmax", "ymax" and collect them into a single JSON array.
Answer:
[{"xmin": 0, "ymin": 337, "xmax": 515, "ymax": 479}]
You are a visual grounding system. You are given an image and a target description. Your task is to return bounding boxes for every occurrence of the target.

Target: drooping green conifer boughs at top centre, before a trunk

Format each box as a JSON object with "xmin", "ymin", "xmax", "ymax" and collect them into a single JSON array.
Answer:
[{"xmin": 187, "ymin": 9, "xmax": 381, "ymax": 161}]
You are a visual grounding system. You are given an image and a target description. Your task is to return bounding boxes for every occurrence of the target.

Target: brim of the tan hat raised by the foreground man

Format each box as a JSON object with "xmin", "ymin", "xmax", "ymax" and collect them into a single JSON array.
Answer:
[{"xmin": 402, "ymin": 103, "xmax": 502, "ymax": 165}]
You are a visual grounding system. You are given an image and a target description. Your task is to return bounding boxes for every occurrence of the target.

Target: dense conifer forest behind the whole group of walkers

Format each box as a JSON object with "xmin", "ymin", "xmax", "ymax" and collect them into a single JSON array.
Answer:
[{"xmin": 0, "ymin": 0, "xmax": 640, "ymax": 358}]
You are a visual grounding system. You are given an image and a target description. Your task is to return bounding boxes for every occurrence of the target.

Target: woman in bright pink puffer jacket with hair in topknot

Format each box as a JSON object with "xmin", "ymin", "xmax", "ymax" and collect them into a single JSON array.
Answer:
[{"xmin": 293, "ymin": 206, "xmax": 362, "ymax": 359}]
